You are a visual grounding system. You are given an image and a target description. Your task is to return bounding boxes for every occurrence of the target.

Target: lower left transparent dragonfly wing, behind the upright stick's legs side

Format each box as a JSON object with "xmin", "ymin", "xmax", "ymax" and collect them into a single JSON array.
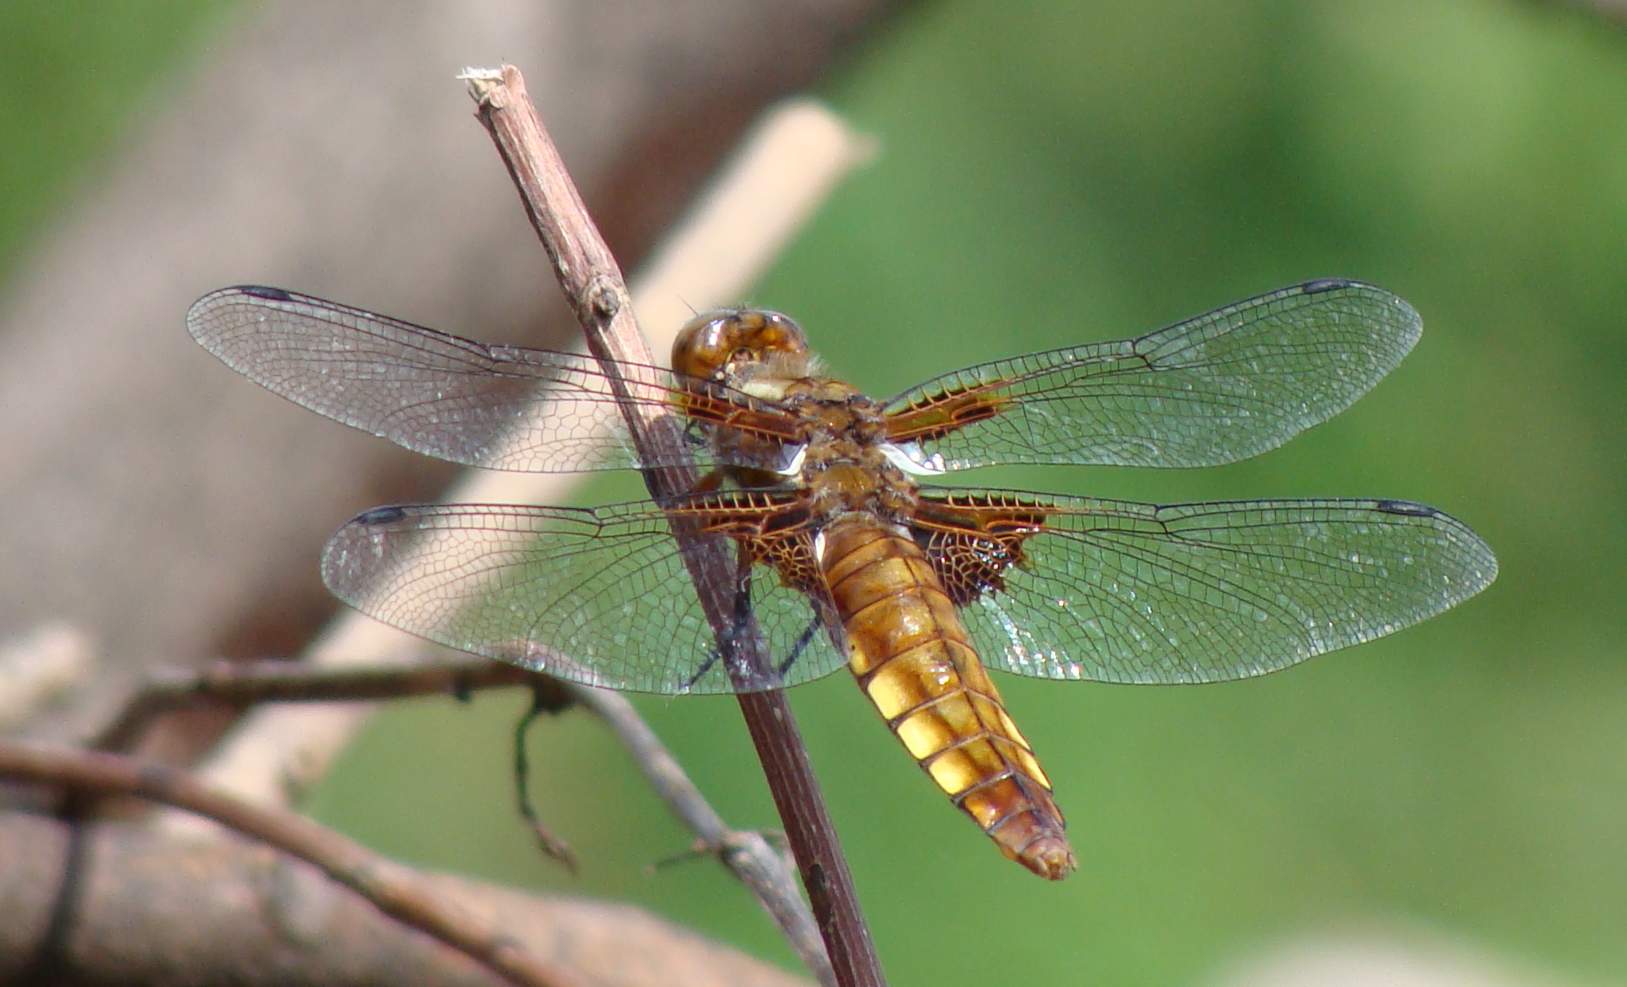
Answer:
[{"xmin": 322, "ymin": 494, "xmax": 844, "ymax": 694}]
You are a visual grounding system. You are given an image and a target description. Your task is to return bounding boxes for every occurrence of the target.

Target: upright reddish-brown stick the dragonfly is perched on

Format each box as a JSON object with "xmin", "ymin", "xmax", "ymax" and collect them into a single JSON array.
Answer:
[{"xmin": 470, "ymin": 65, "xmax": 883, "ymax": 987}]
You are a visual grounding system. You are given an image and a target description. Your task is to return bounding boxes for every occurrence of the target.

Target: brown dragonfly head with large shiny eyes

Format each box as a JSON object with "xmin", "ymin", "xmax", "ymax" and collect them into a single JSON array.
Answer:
[{"xmin": 672, "ymin": 309, "xmax": 812, "ymax": 385}]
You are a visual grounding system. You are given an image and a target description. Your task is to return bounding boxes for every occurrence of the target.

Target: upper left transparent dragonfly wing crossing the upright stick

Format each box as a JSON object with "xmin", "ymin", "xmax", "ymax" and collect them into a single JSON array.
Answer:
[{"xmin": 187, "ymin": 286, "xmax": 789, "ymax": 473}]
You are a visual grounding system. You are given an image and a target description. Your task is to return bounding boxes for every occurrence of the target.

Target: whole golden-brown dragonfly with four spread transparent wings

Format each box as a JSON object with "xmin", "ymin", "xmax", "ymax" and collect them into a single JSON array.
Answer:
[{"xmin": 187, "ymin": 278, "xmax": 1497, "ymax": 880}]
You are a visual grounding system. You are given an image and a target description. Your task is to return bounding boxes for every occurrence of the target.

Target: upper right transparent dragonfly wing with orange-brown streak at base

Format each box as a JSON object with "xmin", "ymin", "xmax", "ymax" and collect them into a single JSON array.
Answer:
[{"xmin": 887, "ymin": 280, "xmax": 1422, "ymax": 470}]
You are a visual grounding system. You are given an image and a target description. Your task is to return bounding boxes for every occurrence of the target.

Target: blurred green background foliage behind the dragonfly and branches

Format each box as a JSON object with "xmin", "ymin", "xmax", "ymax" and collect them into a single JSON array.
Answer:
[{"xmin": 0, "ymin": 0, "xmax": 1627, "ymax": 985}]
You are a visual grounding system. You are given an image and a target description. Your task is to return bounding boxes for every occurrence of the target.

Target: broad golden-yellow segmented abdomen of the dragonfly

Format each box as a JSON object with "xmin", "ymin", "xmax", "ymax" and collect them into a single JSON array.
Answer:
[{"xmin": 820, "ymin": 519, "xmax": 1075, "ymax": 880}]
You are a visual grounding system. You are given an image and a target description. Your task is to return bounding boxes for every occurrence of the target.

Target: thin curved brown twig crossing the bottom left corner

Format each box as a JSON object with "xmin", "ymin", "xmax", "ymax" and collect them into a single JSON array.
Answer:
[{"xmin": 0, "ymin": 741, "xmax": 578, "ymax": 987}]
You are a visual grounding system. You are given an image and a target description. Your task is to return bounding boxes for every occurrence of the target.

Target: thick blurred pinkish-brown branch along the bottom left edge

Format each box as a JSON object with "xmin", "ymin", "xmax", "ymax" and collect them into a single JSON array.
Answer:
[{"xmin": 0, "ymin": 811, "xmax": 807, "ymax": 987}]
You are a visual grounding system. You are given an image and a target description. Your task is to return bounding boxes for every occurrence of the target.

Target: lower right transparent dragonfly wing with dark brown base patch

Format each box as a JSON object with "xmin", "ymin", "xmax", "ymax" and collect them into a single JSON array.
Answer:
[{"xmin": 914, "ymin": 489, "xmax": 1497, "ymax": 683}]
